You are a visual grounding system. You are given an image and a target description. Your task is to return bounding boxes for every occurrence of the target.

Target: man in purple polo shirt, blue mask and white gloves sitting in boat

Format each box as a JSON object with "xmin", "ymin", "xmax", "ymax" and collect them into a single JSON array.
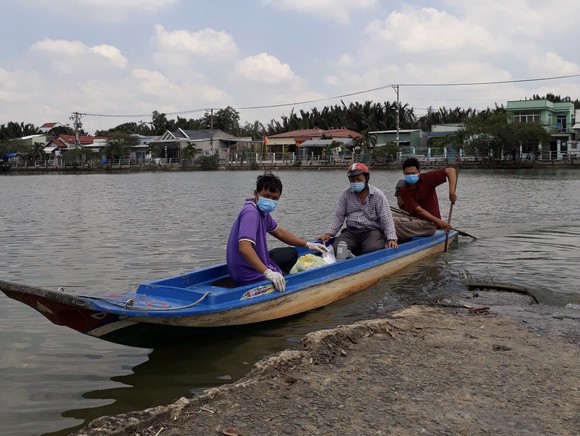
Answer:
[{"xmin": 226, "ymin": 171, "xmax": 327, "ymax": 291}]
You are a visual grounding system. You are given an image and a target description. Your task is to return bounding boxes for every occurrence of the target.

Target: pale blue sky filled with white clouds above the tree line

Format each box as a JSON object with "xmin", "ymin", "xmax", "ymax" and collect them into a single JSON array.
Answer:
[{"xmin": 0, "ymin": 0, "xmax": 580, "ymax": 134}]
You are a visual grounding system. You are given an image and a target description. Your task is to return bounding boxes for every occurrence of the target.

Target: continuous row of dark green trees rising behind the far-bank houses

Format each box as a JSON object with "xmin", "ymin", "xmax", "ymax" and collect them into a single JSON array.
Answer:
[{"xmin": 0, "ymin": 94, "xmax": 580, "ymax": 161}]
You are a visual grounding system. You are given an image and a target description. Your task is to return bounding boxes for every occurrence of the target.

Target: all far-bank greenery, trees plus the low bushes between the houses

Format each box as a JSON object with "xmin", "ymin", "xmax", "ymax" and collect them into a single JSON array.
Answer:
[{"xmin": 0, "ymin": 94, "xmax": 580, "ymax": 163}]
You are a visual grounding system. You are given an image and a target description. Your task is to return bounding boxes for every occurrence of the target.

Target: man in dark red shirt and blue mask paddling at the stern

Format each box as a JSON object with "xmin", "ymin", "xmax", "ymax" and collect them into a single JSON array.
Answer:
[{"xmin": 393, "ymin": 158, "xmax": 457, "ymax": 242}]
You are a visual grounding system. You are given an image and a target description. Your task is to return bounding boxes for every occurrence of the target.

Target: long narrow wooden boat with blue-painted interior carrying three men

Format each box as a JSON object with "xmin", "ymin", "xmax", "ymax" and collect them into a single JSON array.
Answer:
[{"xmin": 0, "ymin": 230, "xmax": 457, "ymax": 347}]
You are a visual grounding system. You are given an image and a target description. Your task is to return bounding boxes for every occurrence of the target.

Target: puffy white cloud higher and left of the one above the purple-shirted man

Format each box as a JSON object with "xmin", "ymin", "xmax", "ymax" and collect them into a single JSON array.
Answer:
[{"xmin": 155, "ymin": 25, "xmax": 238, "ymax": 61}]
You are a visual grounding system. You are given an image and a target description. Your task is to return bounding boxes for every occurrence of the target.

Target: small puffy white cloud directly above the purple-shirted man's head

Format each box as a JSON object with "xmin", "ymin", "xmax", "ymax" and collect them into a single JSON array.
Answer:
[{"xmin": 235, "ymin": 53, "xmax": 296, "ymax": 83}]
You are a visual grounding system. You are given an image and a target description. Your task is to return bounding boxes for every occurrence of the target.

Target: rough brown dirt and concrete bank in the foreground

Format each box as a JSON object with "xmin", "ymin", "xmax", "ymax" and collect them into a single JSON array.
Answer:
[{"xmin": 76, "ymin": 291, "xmax": 580, "ymax": 436}]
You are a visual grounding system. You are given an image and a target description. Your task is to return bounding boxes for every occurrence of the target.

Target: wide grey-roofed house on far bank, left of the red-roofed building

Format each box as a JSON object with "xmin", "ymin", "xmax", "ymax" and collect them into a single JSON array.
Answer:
[{"xmin": 151, "ymin": 129, "xmax": 254, "ymax": 159}]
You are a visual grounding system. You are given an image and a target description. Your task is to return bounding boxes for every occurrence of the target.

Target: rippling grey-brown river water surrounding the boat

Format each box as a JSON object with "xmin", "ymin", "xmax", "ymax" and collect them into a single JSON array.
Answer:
[{"xmin": 0, "ymin": 170, "xmax": 580, "ymax": 436}]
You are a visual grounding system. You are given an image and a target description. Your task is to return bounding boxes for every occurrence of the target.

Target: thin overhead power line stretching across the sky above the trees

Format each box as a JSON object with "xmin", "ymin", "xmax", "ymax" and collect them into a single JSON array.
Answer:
[{"xmin": 78, "ymin": 74, "xmax": 580, "ymax": 118}]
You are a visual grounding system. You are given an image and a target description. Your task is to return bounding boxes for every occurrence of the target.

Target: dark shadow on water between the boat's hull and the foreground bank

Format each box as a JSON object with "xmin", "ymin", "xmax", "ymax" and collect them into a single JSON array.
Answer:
[{"xmin": 45, "ymin": 314, "xmax": 318, "ymax": 436}]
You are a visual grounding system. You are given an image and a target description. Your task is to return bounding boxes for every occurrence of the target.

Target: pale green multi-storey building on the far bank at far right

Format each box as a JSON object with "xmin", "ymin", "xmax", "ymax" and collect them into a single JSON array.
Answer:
[{"xmin": 506, "ymin": 99, "xmax": 575, "ymax": 160}]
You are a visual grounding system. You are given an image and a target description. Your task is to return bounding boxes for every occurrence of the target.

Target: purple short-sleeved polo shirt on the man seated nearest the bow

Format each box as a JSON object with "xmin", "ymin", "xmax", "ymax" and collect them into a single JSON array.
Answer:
[{"xmin": 226, "ymin": 198, "xmax": 282, "ymax": 286}]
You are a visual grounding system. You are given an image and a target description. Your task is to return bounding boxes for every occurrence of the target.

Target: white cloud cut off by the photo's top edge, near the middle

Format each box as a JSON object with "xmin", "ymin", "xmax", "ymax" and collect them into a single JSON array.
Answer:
[{"xmin": 264, "ymin": 0, "xmax": 377, "ymax": 24}]
